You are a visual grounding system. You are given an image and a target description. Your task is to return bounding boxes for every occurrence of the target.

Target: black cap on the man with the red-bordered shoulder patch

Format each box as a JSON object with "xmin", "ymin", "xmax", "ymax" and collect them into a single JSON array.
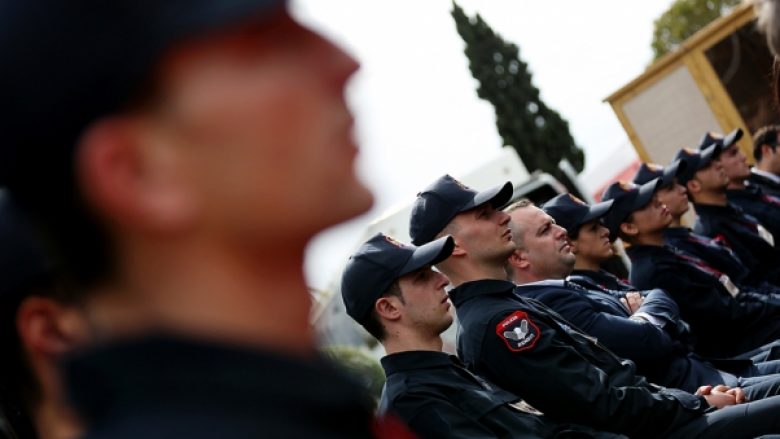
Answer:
[{"xmin": 409, "ymin": 175, "xmax": 514, "ymax": 245}]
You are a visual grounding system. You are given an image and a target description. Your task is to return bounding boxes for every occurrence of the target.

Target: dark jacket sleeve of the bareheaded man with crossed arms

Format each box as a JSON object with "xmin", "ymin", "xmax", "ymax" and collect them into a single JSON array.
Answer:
[{"xmin": 537, "ymin": 292, "xmax": 675, "ymax": 361}]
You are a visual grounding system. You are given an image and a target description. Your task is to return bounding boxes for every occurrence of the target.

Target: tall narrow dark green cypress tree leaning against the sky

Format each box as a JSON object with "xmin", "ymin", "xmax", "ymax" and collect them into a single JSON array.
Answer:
[{"xmin": 452, "ymin": 2, "xmax": 585, "ymax": 177}]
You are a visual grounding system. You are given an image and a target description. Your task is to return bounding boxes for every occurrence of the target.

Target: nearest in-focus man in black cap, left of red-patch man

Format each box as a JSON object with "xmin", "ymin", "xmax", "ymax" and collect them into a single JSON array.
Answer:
[{"xmin": 341, "ymin": 234, "xmax": 617, "ymax": 439}]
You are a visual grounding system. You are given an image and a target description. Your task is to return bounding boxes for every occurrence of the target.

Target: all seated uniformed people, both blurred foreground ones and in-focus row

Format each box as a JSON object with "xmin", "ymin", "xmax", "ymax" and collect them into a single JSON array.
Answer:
[{"xmin": 6, "ymin": 0, "xmax": 780, "ymax": 439}]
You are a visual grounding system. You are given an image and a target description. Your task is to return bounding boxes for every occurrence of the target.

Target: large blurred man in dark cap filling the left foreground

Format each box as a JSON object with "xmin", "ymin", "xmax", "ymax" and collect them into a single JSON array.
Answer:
[{"xmin": 0, "ymin": 0, "xmax": 394, "ymax": 438}]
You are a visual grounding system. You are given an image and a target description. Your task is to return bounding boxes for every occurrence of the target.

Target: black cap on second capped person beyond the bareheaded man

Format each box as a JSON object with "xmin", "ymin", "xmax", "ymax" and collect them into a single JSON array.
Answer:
[{"xmin": 601, "ymin": 178, "xmax": 661, "ymax": 239}]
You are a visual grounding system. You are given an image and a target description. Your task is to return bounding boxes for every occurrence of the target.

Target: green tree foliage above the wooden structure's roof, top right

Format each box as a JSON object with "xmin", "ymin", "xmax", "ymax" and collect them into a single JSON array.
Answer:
[{"xmin": 652, "ymin": 0, "xmax": 742, "ymax": 60}]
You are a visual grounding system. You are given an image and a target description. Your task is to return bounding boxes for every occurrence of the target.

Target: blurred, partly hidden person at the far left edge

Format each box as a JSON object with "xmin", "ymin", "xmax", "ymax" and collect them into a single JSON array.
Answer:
[{"xmin": 0, "ymin": 191, "xmax": 88, "ymax": 439}]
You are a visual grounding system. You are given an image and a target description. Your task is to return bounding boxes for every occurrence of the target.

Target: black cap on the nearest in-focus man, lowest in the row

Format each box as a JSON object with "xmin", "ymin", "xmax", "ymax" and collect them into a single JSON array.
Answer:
[{"xmin": 341, "ymin": 233, "xmax": 455, "ymax": 324}]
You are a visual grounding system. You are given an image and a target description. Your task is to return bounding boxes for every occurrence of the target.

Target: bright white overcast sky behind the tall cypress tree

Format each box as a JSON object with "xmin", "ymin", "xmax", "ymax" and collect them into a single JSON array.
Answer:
[{"xmin": 293, "ymin": 0, "xmax": 671, "ymax": 296}]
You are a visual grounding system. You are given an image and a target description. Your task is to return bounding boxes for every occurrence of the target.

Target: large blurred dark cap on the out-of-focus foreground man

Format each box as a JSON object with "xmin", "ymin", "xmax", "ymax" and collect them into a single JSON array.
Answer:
[{"xmin": 0, "ymin": 0, "xmax": 286, "ymax": 192}]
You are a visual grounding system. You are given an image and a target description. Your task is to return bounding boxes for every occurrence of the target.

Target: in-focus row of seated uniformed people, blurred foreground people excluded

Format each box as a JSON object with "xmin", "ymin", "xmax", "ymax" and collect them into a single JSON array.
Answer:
[{"xmin": 342, "ymin": 126, "xmax": 780, "ymax": 438}]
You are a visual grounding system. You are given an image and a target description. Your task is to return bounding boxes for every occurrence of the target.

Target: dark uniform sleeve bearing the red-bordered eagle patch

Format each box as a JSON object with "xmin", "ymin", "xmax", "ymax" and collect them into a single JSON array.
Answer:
[{"xmin": 478, "ymin": 311, "xmax": 707, "ymax": 437}]
